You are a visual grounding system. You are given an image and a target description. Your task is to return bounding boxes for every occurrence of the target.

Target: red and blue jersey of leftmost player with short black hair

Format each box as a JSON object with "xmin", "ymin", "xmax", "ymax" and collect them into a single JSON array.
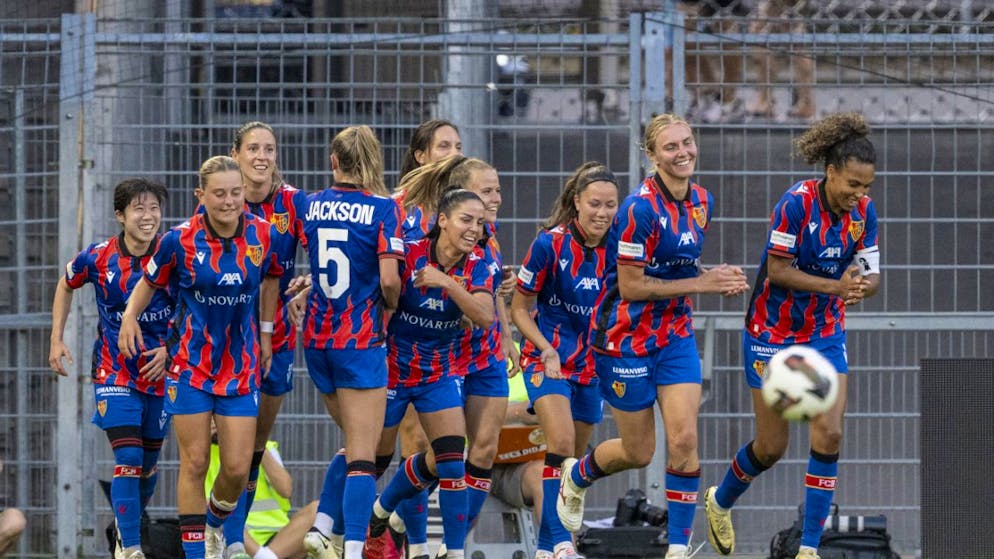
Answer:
[{"xmin": 65, "ymin": 233, "xmax": 175, "ymax": 396}]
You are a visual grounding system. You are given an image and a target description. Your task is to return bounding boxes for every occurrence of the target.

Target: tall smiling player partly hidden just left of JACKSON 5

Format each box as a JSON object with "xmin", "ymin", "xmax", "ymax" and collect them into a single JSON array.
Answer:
[{"xmin": 224, "ymin": 121, "xmax": 306, "ymax": 559}]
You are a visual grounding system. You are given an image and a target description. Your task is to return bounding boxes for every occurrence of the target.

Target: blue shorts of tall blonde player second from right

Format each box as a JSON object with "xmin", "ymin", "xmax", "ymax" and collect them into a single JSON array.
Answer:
[{"xmin": 594, "ymin": 336, "xmax": 701, "ymax": 411}]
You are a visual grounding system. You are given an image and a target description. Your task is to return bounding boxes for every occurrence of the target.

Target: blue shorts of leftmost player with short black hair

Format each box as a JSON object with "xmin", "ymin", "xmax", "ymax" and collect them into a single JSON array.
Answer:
[{"xmin": 93, "ymin": 384, "xmax": 170, "ymax": 439}]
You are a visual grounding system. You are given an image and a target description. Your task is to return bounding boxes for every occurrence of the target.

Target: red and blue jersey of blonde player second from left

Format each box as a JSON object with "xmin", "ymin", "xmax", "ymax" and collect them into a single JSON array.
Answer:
[{"xmin": 145, "ymin": 212, "xmax": 283, "ymax": 396}]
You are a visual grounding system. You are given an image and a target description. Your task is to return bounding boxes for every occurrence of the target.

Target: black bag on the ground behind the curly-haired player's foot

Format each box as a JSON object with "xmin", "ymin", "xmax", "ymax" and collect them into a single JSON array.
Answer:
[{"xmin": 769, "ymin": 503, "xmax": 901, "ymax": 559}]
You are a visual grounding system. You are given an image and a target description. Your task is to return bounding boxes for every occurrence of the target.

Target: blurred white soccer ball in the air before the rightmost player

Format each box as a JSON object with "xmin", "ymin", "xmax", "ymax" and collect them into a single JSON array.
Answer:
[{"xmin": 762, "ymin": 345, "xmax": 839, "ymax": 421}]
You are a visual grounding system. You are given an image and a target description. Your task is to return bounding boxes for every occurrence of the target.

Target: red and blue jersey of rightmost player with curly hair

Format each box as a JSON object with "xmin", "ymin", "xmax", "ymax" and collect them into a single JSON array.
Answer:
[{"xmin": 746, "ymin": 179, "xmax": 877, "ymax": 345}]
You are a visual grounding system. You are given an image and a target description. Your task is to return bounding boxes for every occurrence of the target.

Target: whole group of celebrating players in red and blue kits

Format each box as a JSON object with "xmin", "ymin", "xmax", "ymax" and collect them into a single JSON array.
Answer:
[{"xmin": 50, "ymin": 113, "xmax": 879, "ymax": 559}]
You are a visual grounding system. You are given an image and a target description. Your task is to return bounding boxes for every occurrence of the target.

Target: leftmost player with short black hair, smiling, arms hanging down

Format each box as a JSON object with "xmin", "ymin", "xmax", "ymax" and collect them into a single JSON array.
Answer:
[{"xmin": 48, "ymin": 179, "xmax": 175, "ymax": 559}]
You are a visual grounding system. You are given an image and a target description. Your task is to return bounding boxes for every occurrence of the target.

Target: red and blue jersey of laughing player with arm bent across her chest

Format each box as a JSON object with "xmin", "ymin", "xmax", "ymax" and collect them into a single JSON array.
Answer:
[{"xmin": 387, "ymin": 238, "xmax": 494, "ymax": 388}]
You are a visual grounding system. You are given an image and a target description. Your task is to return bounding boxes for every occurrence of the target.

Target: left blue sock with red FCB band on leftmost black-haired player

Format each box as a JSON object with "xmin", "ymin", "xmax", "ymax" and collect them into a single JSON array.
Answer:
[{"xmin": 110, "ymin": 444, "xmax": 143, "ymax": 547}]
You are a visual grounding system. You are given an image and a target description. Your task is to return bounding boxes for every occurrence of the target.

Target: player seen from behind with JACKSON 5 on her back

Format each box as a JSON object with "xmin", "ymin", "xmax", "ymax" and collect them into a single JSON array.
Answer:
[{"xmin": 297, "ymin": 126, "xmax": 404, "ymax": 559}]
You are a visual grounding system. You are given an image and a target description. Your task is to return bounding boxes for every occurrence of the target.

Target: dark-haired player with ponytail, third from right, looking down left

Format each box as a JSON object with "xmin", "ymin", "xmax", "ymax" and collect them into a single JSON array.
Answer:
[{"xmin": 511, "ymin": 161, "xmax": 618, "ymax": 559}]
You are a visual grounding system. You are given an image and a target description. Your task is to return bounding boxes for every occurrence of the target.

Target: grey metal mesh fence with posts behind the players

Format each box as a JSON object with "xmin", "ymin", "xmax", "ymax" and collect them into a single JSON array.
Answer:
[{"xmin": 0, "ymin": 6, "xmax": 994, "ymax": 557}]
